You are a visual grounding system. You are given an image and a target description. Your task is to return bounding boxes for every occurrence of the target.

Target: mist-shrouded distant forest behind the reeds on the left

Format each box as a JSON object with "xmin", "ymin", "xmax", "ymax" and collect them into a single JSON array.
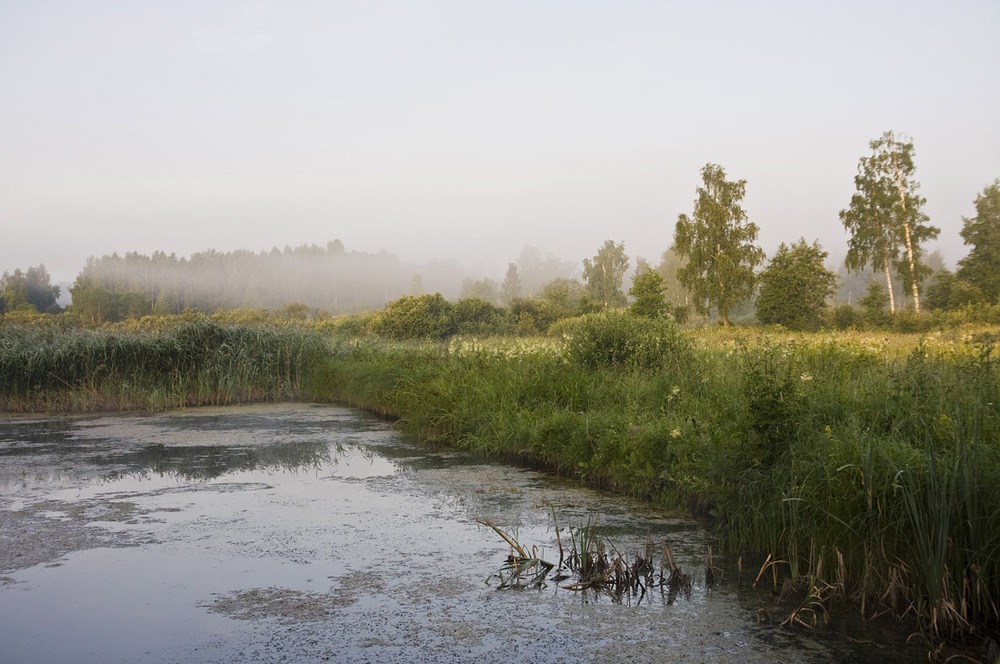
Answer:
[{"xmin": 70, "ymin": 240, "xmax": 472, "ymax": 322}]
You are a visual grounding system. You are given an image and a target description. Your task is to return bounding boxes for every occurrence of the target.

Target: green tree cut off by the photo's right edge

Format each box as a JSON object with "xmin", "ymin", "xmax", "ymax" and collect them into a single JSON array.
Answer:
[{"xmin": 958, "ymin": 180, "xmax": 1000, "ymax": 304}]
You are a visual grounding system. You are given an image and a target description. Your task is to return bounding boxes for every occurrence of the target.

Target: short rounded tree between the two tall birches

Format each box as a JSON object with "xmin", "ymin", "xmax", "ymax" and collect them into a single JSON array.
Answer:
[{"xmin": 756, "ymin": 238, "xmax": 837, "ymax": 330}]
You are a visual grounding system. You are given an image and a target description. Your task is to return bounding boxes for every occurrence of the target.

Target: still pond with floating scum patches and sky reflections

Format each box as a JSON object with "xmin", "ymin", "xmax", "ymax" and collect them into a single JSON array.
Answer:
[{"xmin": 0, "ymin": 404, "xmax": 920, "ymax": 664}]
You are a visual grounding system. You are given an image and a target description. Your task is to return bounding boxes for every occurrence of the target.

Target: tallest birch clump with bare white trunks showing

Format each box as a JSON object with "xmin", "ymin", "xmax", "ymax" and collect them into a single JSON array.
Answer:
[{"xmin": 840, "ymin": 131, "xmax": 940, "ymax": 313}]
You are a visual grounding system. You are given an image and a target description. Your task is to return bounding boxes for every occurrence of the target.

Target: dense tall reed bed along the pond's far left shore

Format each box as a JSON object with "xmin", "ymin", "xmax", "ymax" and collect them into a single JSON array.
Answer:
[{"xmin": 0, "ymin": 317, "xmax": 326, "ymax": 412}]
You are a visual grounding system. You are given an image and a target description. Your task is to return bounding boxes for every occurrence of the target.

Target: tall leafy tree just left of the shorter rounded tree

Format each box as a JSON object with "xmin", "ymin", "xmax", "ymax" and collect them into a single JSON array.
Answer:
[{"xmin": 674, "ymin": 164, "xmax": 764, "ymax": 325}]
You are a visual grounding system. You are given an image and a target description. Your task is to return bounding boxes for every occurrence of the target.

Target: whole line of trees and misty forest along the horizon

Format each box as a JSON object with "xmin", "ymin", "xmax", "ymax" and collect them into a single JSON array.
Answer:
[{"xmin": 0, "ymin": 132, "xmax": 1000, "ymax": 332}]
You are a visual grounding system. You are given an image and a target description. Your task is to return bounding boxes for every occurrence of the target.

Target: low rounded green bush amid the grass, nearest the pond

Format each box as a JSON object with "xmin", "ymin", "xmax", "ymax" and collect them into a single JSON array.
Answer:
[{"xmin": 565, "ymin": 311, "xmax": 689, "ymax": 369}]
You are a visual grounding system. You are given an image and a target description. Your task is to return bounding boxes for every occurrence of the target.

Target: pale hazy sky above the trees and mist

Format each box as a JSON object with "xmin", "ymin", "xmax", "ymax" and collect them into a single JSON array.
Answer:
[{"xmin": 0, "ymin": 0, "xmax": 1000, "ymax": 282}]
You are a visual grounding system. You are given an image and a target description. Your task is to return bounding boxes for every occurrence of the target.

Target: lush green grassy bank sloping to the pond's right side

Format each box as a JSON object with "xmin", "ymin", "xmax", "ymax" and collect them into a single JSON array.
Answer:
[{"xmin": 319, "ymin": 318, "xmax": 1000, "ymax": 642}]
